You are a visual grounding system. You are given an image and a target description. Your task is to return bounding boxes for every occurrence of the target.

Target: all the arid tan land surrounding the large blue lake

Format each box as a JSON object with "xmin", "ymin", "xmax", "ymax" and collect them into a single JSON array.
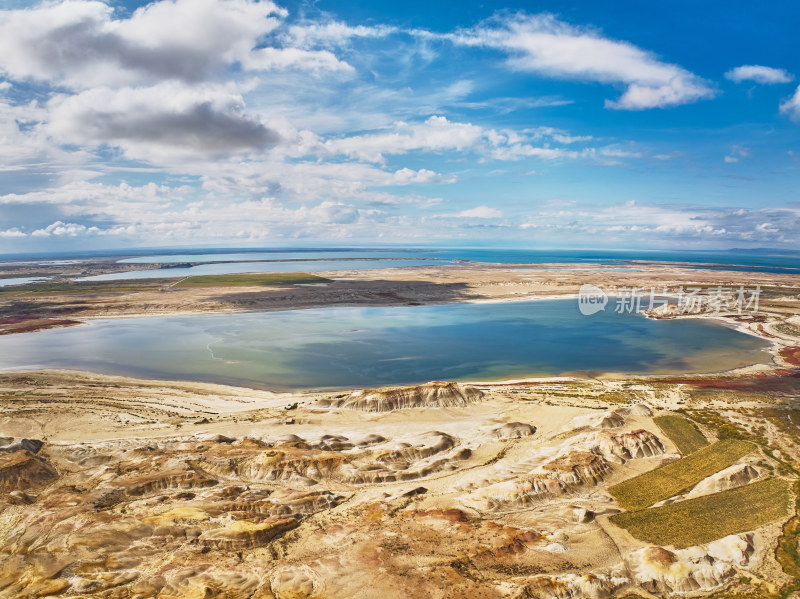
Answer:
[{"xmin": 0, "ymin": 263, "xmax": 800, "ymax": 599}]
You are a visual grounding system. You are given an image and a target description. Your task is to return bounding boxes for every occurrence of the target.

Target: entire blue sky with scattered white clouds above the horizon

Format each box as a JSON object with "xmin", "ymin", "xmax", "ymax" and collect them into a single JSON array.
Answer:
[{"xmin": 0, "ymin": 0, "xmax": 800, "ymax": 252}]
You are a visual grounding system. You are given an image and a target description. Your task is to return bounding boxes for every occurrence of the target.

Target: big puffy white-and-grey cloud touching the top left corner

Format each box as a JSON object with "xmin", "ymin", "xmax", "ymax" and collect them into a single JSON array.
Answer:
[{"xmin": 0, "ymin": 0, "xmax": 349, "ymax": 89}]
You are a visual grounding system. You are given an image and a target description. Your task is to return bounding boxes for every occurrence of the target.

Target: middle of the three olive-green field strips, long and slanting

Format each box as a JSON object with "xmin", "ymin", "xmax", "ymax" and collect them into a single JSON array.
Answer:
[{"xmin": 609, "ymin": 439, "xmax": 756, "ymax": 510}]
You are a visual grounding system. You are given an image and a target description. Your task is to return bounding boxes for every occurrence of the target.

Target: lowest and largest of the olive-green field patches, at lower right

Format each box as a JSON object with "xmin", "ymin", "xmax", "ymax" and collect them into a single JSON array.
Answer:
[{"xmin": 611, "ymin": 478, "xmax": 792, "ymax": 548}]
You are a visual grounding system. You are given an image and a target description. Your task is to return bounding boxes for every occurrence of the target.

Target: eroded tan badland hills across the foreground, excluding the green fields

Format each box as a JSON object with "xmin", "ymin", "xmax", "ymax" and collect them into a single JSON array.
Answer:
[{"xmin": 0, "ymin": 383, "xmax": 792, "ymax": 599}]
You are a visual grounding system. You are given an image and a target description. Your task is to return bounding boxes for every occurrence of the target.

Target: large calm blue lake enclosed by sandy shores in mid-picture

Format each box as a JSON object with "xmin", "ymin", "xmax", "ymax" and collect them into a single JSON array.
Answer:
[{"xmin": 0, "ymin": 300, "xmax": 768, "ymax": 389}]
